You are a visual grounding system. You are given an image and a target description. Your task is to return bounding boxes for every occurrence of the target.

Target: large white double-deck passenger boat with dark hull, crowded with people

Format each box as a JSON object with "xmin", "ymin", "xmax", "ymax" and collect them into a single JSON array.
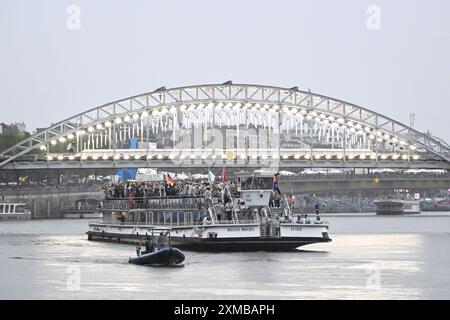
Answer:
[{"xmin": 87, "ymin": 175, "xmax": 331, "ymax": 251}]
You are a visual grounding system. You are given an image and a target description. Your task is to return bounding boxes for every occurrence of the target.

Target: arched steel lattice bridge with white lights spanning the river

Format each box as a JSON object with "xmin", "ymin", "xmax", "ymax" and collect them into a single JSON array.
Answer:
[{"xmin": 0, "ymin": 81, "xmax": 450, "ymax": 170}]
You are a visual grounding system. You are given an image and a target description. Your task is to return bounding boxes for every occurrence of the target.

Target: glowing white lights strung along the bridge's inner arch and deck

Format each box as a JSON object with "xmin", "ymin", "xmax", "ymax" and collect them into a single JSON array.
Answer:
[{"xmin": 40, "ymin": 102, "xmax": 420, "ymax": 160}]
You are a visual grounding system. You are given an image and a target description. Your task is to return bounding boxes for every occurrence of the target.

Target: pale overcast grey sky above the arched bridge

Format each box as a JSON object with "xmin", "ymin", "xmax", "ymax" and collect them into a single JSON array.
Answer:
[{"xmin": 0, "ymin": 0, "xmax": 450, "ymax": 142}]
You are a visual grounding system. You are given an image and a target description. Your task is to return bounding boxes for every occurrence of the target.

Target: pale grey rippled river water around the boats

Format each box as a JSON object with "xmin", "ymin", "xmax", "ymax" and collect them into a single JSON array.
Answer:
[{"xmin": 0, "ymin": 213, "xmax": 450, "ymax": 299}]
